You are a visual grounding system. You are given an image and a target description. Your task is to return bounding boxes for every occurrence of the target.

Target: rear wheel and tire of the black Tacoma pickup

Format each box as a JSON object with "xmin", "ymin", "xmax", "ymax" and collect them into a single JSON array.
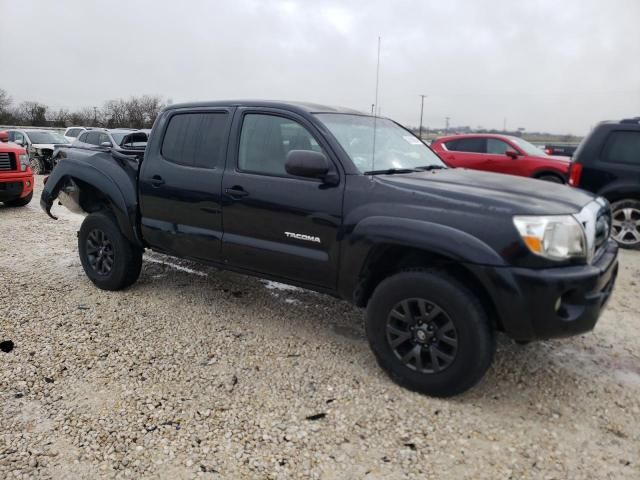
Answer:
[{"xmin": 78, "ymin": 212, "xmax": 142, "ymax": 290}]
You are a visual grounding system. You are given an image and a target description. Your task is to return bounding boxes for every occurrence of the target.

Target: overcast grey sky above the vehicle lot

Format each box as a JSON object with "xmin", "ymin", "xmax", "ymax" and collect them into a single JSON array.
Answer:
[{"xmin": 0, "ymin": 0, "xmax": 640, "ymax": 134}]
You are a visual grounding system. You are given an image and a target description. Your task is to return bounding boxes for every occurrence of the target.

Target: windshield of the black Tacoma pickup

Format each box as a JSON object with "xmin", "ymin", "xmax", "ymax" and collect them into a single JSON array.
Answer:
[{"xmin": 316, "ymin": 113, "xmax": 446, "ymax": 173}]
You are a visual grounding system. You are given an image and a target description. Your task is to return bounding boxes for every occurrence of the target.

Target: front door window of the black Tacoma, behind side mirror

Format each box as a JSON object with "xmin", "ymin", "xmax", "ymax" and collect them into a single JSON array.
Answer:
[{"xmin": 238, "ymin": 113, "xmax": 322, "ymax": 177}]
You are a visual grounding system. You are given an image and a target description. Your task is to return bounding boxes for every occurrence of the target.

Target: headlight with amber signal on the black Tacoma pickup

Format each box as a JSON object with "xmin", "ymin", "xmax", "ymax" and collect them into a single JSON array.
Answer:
[{"xmin": 513, "ymin": 215, "xmax": 587, "ymax": 260}]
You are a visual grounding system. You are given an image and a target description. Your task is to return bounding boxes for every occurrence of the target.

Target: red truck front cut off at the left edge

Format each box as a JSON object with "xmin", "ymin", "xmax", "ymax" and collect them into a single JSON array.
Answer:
[{"xmin": 0, "ymin": 132, "xmax": 33, "ymax": 207}]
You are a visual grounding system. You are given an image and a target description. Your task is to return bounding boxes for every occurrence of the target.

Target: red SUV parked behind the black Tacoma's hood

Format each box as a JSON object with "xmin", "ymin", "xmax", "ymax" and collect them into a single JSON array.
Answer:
[{"xmin": 431, "ymin": 134, "xmax": 570, "ymax": 183}]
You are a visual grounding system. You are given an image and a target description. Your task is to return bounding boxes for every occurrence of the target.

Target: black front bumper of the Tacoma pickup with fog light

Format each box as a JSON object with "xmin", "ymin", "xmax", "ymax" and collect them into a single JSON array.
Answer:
[{"xmin": 469, "ymin": 240, "xmax": 618, "ymax": 341}]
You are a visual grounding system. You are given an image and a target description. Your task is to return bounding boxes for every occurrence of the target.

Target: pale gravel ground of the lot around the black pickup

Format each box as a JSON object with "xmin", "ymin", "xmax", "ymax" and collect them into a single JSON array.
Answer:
[{"xmin": 0, "ymin": 177, "xmax": 640, "ymax": 479}]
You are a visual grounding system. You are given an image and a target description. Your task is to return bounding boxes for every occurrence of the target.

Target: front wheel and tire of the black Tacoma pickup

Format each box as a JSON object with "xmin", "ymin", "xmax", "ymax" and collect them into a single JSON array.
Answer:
[{"xmin": 366, "ymin": 270, "xmax": 496, "ymax": 397}]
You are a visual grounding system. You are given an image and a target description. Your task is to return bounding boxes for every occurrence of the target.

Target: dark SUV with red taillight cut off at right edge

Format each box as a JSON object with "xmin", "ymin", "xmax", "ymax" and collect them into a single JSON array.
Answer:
[{"xmin": 569, "ymin": 117, "xmax": 640, "ymax": 248}]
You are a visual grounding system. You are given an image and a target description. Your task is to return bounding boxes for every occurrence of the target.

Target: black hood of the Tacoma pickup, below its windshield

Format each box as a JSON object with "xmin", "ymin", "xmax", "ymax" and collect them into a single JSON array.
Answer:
[{"xmin": 376, "ymin": 168, "xmax": 594, "ymax": 215}]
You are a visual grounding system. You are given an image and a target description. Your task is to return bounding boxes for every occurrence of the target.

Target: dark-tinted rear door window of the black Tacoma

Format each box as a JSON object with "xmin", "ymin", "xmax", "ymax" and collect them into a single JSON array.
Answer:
[{"xmin": 162, "ymin": 112, "xmax": 229, "ymax": 168}]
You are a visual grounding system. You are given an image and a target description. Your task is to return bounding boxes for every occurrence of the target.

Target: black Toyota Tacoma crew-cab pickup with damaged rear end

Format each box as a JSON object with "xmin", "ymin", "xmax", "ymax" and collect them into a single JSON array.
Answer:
[{"xmin": 41, "ymin": 102, "xmax": 618, "ymax": 396}]
